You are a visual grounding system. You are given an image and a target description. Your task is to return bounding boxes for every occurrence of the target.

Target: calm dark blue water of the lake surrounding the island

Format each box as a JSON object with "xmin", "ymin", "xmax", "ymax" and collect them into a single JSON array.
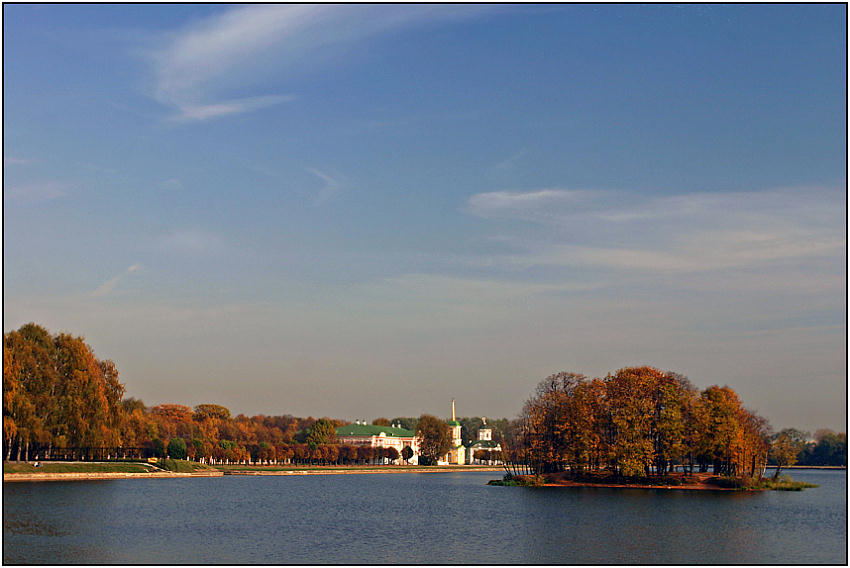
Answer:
[{"xmin": 3, "ymin": 470, "xmax": 847, "ymax": 564}]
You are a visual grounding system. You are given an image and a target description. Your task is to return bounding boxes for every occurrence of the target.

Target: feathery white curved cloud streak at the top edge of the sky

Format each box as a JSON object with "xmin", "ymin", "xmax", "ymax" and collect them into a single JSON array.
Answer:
[{"xmin": 150, "ymin": 4, "xmax": 481, "ymax": 121}]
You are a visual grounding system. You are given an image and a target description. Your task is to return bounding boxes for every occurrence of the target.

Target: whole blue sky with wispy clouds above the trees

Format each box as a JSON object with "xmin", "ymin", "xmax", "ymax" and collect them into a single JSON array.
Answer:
[{"xmin": 3, "ymin": 4, "xmax": 847, "ymax": 431}]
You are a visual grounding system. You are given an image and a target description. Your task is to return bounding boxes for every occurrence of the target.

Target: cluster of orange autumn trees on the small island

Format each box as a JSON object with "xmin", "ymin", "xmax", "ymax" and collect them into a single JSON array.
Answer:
[{"xmin": 507, "ymin": 367, "xmax": 772, "ymax": 477}]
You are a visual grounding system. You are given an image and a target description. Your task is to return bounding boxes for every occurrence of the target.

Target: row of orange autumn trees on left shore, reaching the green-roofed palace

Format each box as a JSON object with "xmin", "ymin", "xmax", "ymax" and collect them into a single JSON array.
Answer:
[{"xmin": 3, "ymin": 323, "xmax": 486, "ymax": 465}]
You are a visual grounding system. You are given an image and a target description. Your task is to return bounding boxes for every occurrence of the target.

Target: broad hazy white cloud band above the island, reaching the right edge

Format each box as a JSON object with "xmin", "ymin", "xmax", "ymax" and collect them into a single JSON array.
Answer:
[{"xmin": 469, "ymin": 187, "xmax": 846, "ymax": 272}]
